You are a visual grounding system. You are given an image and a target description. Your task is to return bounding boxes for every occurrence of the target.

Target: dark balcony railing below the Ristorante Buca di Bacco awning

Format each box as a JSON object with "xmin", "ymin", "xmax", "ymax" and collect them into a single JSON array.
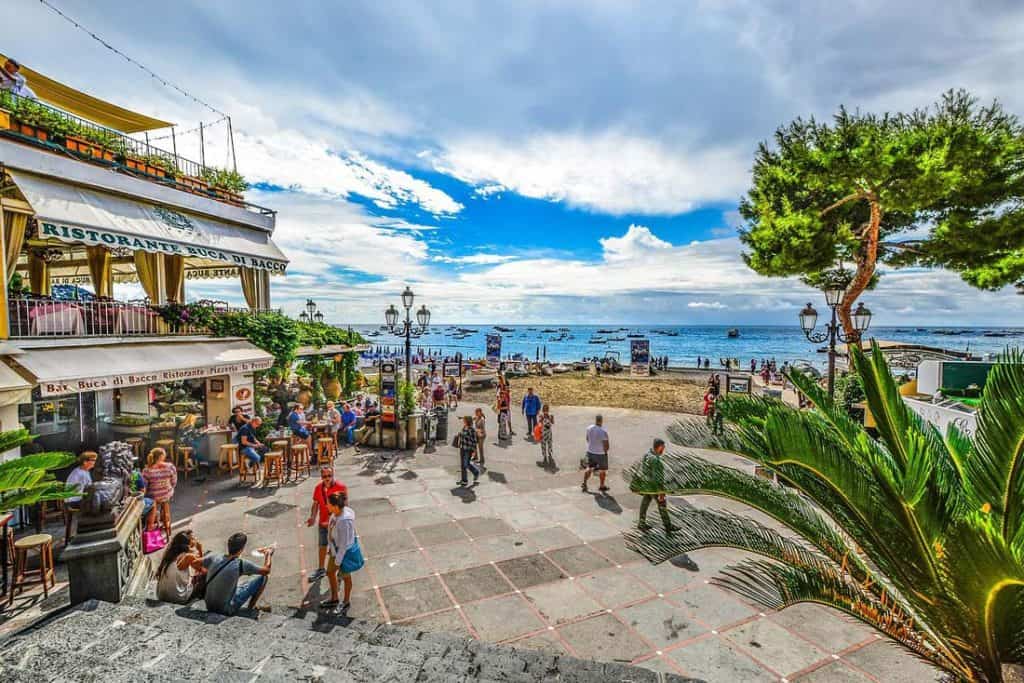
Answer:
[{"xmin": 7, "ymin": 298, "xmax": 260, "ymax": 339}]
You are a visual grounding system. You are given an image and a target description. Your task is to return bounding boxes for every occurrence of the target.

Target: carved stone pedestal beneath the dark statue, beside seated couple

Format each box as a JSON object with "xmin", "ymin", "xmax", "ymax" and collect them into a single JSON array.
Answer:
[{"xmin": 61, "ymin": 497, "xmax": 150, "ymax": 605}]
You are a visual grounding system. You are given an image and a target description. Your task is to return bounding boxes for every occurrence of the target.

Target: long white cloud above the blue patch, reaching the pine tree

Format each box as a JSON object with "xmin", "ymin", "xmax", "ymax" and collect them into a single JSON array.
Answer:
[{"xmin": 433, "ymin": 131, "xmax": 750, "ymax": 215}]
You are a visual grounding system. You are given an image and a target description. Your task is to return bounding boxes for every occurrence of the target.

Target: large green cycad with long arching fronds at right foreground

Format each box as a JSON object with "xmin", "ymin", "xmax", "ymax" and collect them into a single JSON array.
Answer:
[{"xmin": 626, "ymin": 346, "xmax": 1024, "ymax": 682}]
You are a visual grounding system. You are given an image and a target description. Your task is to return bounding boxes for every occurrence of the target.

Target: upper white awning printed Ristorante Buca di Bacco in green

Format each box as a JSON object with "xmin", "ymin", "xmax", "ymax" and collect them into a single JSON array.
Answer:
[{"xmin": 7, "ymin": 169, "xmax": 288, "ymax": 272}]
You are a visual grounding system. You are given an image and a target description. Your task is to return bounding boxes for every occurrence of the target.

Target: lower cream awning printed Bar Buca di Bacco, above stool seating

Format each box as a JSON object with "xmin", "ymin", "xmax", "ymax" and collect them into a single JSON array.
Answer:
[{"xmin": 14, "ymin": 338, "xmax": 273, "ymax": 396}]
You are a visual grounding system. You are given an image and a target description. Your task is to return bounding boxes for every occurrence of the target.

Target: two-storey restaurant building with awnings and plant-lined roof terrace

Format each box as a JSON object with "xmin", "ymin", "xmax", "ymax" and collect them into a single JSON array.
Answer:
[{"xmin": 0, "ymin": 61, "xmax": 287, "ymax": 458}]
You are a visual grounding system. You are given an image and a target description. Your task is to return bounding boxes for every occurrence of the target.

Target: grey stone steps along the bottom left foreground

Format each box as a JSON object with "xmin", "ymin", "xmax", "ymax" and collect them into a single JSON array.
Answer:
[{"xmin": 0, "ymin": 598, "xmax": 693, "ymax": 683}]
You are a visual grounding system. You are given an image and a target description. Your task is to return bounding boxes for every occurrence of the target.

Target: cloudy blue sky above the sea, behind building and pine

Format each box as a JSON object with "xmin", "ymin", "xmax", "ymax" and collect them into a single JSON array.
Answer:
[{"xmin": 6, "ymin": 0, "xmax": 1024, "ymax": 326}]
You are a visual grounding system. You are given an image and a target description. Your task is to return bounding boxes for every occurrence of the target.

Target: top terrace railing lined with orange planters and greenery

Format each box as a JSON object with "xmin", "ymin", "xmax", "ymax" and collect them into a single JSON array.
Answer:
[{"xmin": 0, "ymin": 90, "xmax": 275, "ymax": 215}]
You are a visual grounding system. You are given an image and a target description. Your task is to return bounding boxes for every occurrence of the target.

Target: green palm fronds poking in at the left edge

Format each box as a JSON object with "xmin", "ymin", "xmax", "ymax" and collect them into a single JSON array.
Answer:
[{"xmin": 0, "ymin": 428, "xmax": 81, "ymax": 512}]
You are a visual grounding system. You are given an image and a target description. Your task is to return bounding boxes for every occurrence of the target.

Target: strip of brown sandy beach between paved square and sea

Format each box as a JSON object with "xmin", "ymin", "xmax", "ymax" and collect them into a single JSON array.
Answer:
[{"xmin": 465, "ymin": 373, "xmax": 703, "ymax": 415}]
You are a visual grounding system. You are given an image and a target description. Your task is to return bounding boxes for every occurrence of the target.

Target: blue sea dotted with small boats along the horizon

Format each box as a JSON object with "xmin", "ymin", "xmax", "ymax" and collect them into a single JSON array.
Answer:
[{"xmin": 352, "ymin": 324, "xmax": 1024, "ymax": 368}]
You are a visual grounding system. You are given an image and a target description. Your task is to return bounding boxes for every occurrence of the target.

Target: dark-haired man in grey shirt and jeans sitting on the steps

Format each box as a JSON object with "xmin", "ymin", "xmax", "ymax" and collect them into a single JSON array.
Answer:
[{"xmin": 203, "ymin": 531, "xmax": 273, "ymax": 616}]
